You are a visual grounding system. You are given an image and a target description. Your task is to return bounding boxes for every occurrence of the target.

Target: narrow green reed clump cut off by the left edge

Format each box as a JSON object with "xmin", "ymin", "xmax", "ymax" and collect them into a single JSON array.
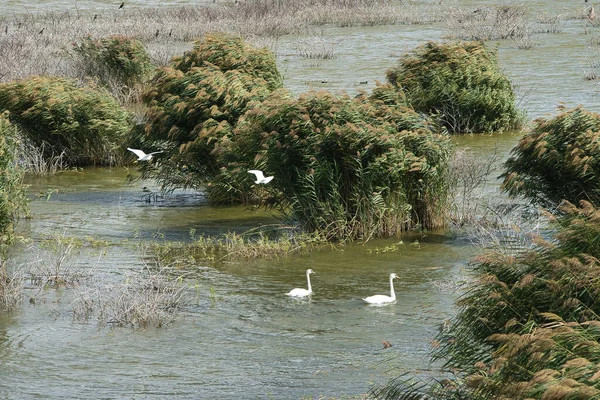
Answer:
[{"xmin": 0, "ymin": 113, "xmax": 28, "ymax": 244}]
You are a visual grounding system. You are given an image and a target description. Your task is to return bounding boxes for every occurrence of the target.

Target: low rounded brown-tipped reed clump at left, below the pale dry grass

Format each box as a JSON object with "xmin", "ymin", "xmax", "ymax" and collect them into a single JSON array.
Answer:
[{"xmin": 0, "ymin": 76, "xmax": 132, "ymax": 166}]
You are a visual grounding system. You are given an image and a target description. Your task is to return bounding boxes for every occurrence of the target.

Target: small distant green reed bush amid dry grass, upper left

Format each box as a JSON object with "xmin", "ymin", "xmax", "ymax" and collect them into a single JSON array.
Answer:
[{"xmin": 73, "ymin": 36, "xmax": 155, "ymax": 102}]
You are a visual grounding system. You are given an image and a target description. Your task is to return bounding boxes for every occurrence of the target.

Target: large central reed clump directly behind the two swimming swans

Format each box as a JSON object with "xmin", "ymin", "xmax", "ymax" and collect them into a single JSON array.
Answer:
[{"xmin": 224, "ymin": 86, "xmax": 451, "ymax": 240}]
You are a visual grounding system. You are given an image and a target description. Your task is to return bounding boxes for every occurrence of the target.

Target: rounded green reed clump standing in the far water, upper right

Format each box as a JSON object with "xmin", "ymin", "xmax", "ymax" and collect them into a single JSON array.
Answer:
[{"xmin": 387, "ymin": 42, "xmax": 523, "ymax": 133}]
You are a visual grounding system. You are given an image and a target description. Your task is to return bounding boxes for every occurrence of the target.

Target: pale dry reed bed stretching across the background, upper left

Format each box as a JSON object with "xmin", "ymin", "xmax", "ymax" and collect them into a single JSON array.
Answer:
[{"xmin": 0, "ymin": 0, "xmax": 439, "ymax": 82}]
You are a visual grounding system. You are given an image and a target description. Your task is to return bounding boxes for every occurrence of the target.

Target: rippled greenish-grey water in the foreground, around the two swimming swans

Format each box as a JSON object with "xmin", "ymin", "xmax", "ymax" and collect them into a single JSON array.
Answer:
[{"xmin": 0, "ymin": 169, "xmax": 472, "ymax": 399}]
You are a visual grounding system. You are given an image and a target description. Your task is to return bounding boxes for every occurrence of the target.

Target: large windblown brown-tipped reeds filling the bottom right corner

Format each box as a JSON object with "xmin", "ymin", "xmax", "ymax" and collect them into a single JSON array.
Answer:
[{"xmin": 436, "ymin": 202, "xmax": 600, "ymax": 399}]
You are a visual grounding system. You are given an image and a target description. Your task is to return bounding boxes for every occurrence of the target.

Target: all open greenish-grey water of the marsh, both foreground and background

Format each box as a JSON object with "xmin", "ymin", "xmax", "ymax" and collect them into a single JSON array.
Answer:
[{"xmin": 0, "ymin": 0, "xmax": 600, "ymax": 399}]
